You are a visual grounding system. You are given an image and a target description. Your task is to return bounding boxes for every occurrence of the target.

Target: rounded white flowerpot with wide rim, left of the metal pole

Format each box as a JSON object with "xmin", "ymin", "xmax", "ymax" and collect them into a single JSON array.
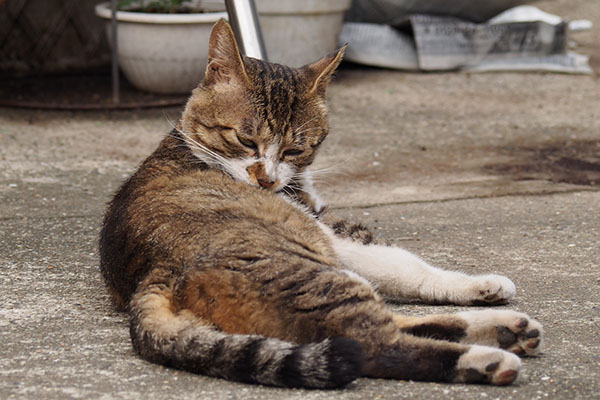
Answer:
[{"xmin": 96, "ymin": 0, "xmax": 227, "ymax": 94}]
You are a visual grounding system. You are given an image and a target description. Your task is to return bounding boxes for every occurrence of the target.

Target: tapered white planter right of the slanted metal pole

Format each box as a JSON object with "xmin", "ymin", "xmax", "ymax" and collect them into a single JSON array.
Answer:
[{"xmin": 256, "ymin": 0, "xmax": 351, "ymax": 67}]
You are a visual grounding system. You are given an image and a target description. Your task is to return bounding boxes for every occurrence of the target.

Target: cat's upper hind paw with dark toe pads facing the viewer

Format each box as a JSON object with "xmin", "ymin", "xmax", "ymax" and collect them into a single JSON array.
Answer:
[{"xmin": 498, "ymin": 312, "xmax": 543, "ymax": 356}]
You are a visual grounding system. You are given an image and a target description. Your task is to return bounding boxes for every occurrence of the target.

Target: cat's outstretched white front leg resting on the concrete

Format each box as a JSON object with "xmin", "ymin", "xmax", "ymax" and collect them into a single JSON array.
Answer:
[{"xmin": 323, "ymin": 227, "xmax": 516, "ymax": 305}]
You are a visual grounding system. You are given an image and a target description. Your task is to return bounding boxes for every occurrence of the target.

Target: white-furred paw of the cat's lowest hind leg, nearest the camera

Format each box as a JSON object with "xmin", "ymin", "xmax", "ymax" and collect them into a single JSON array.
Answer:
[{"xmin": 456, "ymin": 346, "xmax": 521, "ymax": 385}]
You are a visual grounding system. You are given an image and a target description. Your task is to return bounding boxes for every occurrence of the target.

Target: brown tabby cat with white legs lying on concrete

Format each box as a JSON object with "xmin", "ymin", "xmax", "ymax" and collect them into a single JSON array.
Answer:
[{"xmin": 100, "ymin": 21, "xmax": 542, "ymax": 388}]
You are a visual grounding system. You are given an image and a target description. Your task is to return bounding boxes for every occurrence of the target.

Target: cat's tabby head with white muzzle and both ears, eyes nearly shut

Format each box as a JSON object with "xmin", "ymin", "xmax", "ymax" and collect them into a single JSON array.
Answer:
[{"xmin": 179, "ymin": 20, "xmax": 344, "ymax": 191}]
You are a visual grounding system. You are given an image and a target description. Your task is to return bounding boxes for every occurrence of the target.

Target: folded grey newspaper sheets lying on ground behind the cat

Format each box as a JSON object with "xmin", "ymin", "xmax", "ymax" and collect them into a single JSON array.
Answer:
[{"xmin": 340, "ymin": 6, "xmax": 592, "ymax": 74}]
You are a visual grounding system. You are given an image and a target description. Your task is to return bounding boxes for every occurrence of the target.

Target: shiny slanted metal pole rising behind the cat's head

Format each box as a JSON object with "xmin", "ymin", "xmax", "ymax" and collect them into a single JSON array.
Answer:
[{"xmin": 224, "ymin": 0, "xmax": 267, "ymax": 61}]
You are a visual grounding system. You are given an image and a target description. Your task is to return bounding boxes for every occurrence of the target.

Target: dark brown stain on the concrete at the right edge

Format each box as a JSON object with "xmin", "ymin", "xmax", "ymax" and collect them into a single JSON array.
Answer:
[{"xmin": 483, "ymin": 140, "xmax": 600, "ymax": 186}]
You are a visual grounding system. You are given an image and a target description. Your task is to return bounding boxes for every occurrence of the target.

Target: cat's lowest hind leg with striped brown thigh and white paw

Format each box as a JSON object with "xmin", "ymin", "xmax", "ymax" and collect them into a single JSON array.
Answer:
[{"xmin": 274, "ymin": 268, "xmax": 521, "ymax": 385}]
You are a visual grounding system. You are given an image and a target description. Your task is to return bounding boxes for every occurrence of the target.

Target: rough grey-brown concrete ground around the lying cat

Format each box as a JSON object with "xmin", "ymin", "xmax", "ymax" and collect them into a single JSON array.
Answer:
[{"xmin": 0, "ymin": 0, "xmax": 600, "ymax": 400}]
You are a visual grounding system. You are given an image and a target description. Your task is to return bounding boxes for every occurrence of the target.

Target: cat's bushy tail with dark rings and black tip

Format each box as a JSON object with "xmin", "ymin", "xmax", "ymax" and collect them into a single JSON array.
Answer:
[{"xmin": 130, "ymin": 268, "xmax": 363, "ymax": 389}]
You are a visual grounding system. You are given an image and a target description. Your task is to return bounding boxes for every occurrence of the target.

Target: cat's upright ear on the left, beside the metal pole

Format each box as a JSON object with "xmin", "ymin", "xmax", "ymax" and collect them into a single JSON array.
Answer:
[{"xmin": 203, "ymin": 19, "xmax": 248, "ymax": 87}]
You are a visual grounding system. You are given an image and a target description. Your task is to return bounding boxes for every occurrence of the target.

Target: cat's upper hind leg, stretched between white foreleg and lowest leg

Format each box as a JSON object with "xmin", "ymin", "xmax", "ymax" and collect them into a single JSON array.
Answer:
[{"xmin": 394, "ymin": 310, "xmax": 544, "ymax": 356}]
